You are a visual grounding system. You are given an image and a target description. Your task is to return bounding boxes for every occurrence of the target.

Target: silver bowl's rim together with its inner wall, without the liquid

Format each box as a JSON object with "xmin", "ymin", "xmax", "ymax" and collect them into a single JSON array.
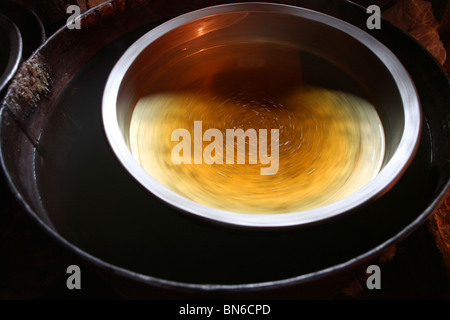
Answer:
[{"xmin": 103, "ymin": 3, "xmax": 422, "ymax": 228}]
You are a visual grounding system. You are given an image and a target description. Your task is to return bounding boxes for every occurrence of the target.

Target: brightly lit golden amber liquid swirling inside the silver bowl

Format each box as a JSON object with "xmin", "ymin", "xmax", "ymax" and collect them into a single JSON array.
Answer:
[{"xmin": 129, "ymin": 43, "xmax": 384, "ymax": 214}]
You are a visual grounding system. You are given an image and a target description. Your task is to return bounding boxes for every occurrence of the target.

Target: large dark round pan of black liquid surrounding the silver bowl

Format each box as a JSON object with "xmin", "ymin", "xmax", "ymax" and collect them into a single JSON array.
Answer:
[{"xmin": 1, "ymin": 0, "xmax": 450, "ymax": 298}]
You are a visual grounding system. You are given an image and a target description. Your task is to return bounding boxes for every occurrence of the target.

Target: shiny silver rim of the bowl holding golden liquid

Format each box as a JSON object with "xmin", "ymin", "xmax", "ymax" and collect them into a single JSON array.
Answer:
[{"xmin": 102, "ymin": 2, "xmax": 423, "ymax": 228}]
